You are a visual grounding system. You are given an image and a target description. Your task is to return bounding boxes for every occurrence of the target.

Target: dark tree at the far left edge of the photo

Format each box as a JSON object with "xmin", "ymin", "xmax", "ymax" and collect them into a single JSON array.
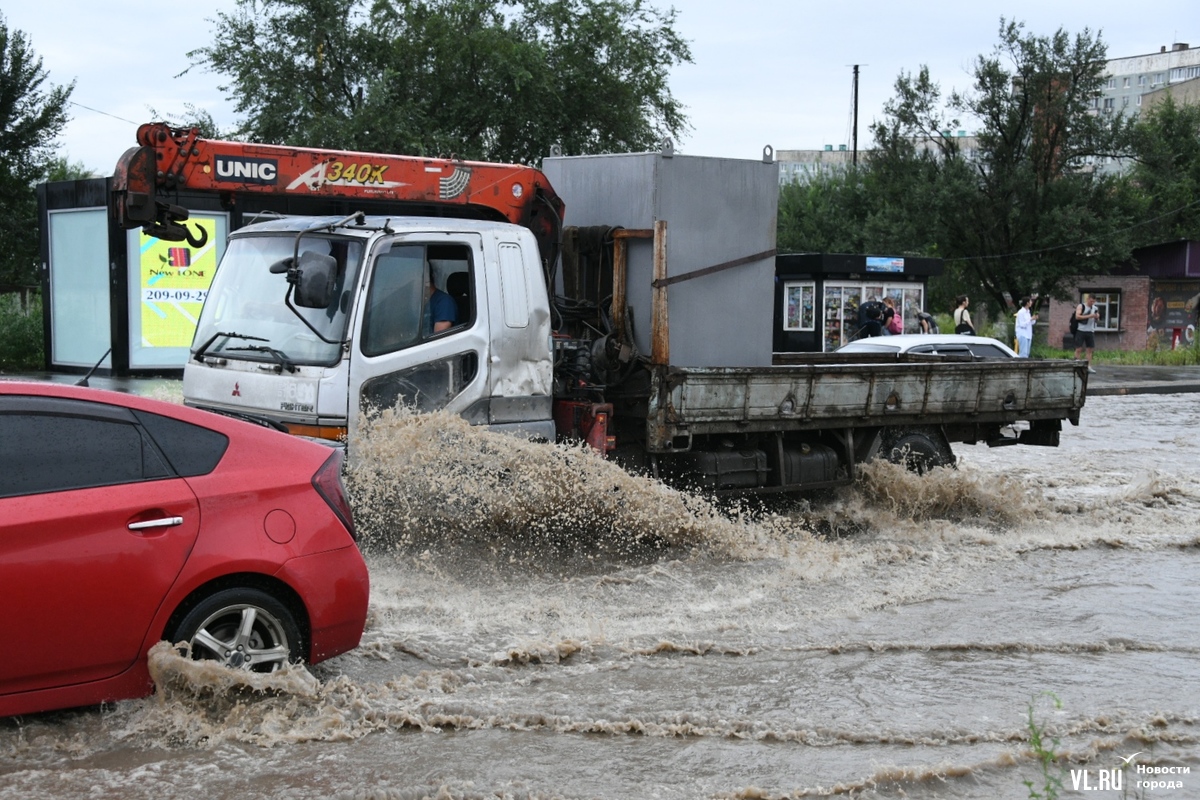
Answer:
[{"xmin": 0, "ymin": 14, "xmax": 74, "ymax": 287}]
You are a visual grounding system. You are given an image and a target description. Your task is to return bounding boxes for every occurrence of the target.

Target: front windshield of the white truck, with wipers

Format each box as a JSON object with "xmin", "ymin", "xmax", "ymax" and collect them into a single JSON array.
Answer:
[{"xmin": 192, "ymin": 234, "xmax": 362, "ymax": 365}]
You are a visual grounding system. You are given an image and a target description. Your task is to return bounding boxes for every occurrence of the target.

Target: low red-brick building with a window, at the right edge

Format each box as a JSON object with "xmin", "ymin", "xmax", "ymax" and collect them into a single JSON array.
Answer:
[{"xmin": 1044, "ymin": 240, "xmax": 1200, "ymax": 350}]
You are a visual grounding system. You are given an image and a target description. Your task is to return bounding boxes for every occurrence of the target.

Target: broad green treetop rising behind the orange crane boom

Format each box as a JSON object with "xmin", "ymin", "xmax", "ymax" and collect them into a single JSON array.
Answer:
[{"xmin": 190, "ymin": 0, "xmax": 691, "ymax": 163}]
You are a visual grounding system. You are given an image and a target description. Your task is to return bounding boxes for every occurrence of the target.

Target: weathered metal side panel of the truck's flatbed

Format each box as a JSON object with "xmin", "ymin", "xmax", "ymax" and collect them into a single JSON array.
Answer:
[{"xmin": 646, "ymin": 359, "xmax": 1087, "ymax": 453}]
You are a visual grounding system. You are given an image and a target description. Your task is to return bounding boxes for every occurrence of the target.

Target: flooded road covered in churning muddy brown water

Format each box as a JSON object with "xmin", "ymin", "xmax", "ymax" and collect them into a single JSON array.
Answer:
[{"xmin": 0, "ymin": 395, "xmax": 1200, "ymax": 800}]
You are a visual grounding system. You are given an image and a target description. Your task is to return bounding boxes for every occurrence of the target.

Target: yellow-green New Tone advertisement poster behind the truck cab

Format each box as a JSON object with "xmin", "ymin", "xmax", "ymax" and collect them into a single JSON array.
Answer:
[{"xmin": 138, "ymin": 217, "xmax": 221, "ymax": 348}]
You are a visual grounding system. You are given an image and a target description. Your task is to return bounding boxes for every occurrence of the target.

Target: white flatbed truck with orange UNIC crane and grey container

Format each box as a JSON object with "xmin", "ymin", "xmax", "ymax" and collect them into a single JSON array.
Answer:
[{"xmin": 112, "ymin": 124, "xmax": 1087, "ymax": 493}]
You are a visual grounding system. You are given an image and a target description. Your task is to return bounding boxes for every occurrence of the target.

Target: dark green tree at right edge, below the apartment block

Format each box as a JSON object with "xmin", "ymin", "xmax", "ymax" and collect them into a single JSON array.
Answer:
[{"xmin": 1130, "ymin": 96, "xmax": 1200, "ymax": 245}]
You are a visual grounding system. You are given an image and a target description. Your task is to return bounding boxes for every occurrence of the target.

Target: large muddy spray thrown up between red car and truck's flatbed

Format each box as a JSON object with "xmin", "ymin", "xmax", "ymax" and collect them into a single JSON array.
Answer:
[{"xmin": 347, "ymin": 410, "xmax": 796, "ymax": 563}]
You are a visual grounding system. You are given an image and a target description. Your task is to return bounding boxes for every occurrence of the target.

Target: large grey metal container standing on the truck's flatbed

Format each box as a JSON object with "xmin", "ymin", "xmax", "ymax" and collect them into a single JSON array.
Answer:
[{"xmin": 542, "ymin": 148, "xmax": 779, "ymax": 367}]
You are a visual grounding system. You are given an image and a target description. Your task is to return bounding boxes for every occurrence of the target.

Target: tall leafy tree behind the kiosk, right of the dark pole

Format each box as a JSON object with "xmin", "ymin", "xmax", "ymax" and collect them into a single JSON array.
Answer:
[{"xmin": 869, "ymin": 19, "xmax": 1135, "ymax": 307}]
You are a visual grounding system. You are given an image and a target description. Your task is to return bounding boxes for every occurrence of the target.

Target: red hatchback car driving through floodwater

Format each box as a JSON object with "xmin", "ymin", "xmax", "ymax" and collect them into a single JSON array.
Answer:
[{"xmin": 0, "ymin": 381, "xmax": 368, "ymax": 716}]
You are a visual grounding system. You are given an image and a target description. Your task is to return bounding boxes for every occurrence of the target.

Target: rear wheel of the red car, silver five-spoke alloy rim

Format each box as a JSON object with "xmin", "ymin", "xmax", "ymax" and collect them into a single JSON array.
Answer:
[{"xmin": 170, "ymin": 589, "xmax": 304, "ymax": 672}]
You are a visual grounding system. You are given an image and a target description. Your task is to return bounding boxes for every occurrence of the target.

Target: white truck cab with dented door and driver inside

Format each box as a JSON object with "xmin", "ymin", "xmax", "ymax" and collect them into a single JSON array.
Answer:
[{"xmin": 184, "ymin": 215, "xmax": 554, "ymax": 440}]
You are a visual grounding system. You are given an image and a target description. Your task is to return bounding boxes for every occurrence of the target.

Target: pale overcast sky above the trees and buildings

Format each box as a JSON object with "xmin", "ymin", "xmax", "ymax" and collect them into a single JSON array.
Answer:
[{"xmin": 2, "ymin": 0, "xmax": 1200, "ymax": 175}]
